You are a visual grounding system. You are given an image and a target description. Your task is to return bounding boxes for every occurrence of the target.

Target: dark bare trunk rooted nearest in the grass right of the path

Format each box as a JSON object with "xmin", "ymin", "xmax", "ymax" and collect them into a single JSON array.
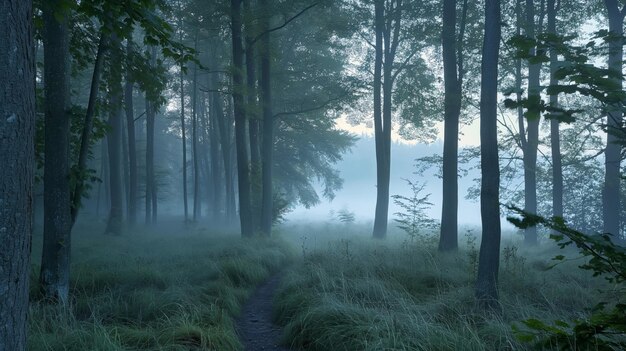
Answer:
[{"xmin": 476, "ymin": 0, "xmax": 501, "ymax": 310}]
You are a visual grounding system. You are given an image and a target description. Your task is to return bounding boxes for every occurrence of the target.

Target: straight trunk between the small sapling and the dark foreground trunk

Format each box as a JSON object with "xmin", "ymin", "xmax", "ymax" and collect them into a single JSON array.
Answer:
[{"xmin": 439, "ymin": 0, "xmax": 467, "ymax": 251}]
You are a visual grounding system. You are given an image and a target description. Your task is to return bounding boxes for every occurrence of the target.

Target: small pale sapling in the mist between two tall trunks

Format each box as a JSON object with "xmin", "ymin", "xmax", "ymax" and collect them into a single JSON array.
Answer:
[{"xmin": 392, "ymin": 179, "xmax": 437, "ymax": 242}]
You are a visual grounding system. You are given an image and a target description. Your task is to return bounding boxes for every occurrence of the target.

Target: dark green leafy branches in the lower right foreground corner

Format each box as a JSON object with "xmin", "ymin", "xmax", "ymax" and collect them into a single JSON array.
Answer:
[{"xmin": 507, "ymin": 206, "xmax": 626, "ymax": 350}]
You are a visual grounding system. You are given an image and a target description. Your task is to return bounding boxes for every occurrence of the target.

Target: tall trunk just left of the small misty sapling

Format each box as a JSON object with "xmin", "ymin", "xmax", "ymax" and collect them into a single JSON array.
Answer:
[{"xmin": 373, "ymin": 0, "xmax": 389, "ymax": 238}]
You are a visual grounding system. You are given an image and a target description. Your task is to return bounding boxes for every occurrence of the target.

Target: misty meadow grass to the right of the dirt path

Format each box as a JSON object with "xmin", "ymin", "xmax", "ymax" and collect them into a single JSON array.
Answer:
[{"xmin": 275, "ymin": 224, "xmax": 609, "ymax": 351}]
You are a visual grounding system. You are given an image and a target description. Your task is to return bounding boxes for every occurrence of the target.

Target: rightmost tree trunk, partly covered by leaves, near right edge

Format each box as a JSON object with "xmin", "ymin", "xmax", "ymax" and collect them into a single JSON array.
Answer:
[{"xmin": 602, "ymin": 0, "xmax": 626, "ymax": 236}]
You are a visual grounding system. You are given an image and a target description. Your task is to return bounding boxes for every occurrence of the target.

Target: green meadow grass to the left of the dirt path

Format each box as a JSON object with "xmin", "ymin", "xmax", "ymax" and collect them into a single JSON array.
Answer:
[{"xmin": 28, "ymin": 220, "xmax": 293, "ymax": 351}]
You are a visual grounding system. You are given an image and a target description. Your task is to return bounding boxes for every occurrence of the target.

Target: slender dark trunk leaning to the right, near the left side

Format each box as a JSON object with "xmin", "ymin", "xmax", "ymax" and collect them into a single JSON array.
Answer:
[{"xmin": 72, "ymin": 31, "xmax": 108, "ymax": 225}]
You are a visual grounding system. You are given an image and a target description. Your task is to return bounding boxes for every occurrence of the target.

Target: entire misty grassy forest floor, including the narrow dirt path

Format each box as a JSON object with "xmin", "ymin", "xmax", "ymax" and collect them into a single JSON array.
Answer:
[{"xmin": 28, "ymin": 222, "xmax": 619, "ymax": 351}]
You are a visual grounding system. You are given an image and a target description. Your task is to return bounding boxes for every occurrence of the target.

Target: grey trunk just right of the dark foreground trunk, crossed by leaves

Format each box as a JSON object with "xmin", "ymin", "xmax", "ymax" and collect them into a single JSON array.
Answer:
[{"xmin": 523, "ymin": 0, "xmax": 541, "ymax": 245}]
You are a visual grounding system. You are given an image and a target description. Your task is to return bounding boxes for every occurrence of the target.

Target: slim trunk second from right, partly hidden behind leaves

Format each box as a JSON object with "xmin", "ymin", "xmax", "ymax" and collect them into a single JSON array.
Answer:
[{"xmin": 547, "ymin": 0, "xmax": 563, "ymax": 217}]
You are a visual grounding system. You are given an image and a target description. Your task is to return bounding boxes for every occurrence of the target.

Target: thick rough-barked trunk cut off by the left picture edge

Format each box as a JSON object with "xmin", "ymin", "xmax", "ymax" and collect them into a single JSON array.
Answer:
[{"xmin": 0, "ymin": 0, "xmax": 35, "ymax": 351}]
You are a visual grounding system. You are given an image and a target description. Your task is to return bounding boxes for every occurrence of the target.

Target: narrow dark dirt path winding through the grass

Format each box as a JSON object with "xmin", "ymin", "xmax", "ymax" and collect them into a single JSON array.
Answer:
[{"xmin": 237, "ymin": 274, "xmax": 289, "ymax": 351}]
